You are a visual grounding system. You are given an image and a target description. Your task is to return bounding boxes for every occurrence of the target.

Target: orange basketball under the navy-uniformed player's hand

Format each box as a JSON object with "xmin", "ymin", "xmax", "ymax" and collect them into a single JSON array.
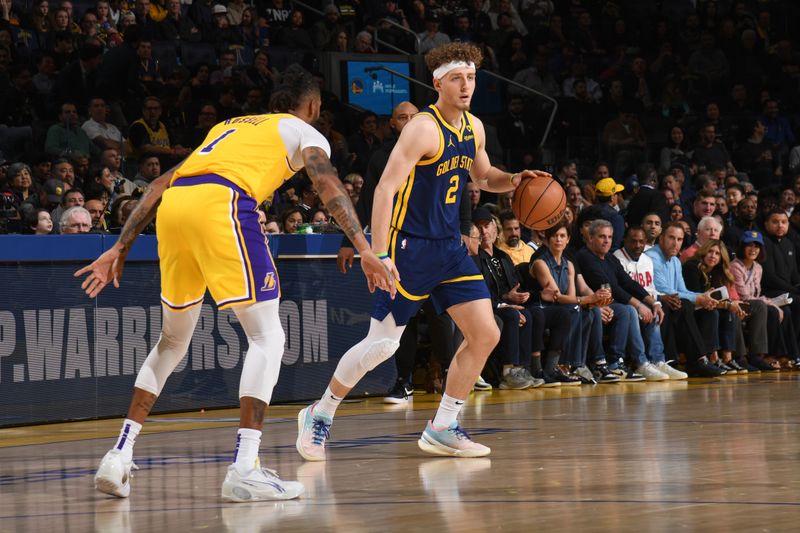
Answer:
[{"xmin": 511, "ymin": 178, "xmax": 567, "ymax": 230}]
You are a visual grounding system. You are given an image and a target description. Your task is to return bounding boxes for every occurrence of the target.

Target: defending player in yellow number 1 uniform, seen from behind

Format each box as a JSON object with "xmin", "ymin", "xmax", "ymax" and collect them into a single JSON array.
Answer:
[{"xmin": 75, "ymin": 67, "xmax": 394, "ymax": 502}]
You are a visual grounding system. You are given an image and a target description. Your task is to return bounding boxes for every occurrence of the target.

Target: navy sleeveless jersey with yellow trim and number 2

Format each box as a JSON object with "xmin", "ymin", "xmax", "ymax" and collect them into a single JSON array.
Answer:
[{"xmin": 391, "ymin": 106, "xmax": 478, "ymax": 239}]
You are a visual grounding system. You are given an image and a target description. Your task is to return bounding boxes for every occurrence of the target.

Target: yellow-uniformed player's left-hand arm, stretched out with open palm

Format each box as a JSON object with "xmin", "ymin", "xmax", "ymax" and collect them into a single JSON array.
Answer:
[{"xmin": 75, "ymin": 164, "xmax": 180, "ymax": 298}]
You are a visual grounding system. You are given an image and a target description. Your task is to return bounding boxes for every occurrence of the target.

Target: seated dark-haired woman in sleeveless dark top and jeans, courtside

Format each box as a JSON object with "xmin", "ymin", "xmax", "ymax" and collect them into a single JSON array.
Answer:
[{"xmin": 529, "ymin": 219, "xmax": 619, "ymax": 386}]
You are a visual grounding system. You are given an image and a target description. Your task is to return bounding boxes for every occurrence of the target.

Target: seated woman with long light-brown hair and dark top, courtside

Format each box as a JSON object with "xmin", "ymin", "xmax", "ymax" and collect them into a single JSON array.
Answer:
[{"xmin": 683, "ymin": 239, "xmax": 752, "ymax": 374}]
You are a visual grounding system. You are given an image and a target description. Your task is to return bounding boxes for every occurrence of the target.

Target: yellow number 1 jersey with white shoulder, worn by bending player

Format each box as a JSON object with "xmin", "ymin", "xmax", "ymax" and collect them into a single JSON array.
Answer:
[{"xmin": 170, "ymin": 113, "xmax": 330, "ymax": 203}]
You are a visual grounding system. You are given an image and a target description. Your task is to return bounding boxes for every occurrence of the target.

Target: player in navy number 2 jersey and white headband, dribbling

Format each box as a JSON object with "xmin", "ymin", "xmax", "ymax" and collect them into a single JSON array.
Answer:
[{"xmin": 297, "ymin": 43, "xmax": 550, "ymax": 461}]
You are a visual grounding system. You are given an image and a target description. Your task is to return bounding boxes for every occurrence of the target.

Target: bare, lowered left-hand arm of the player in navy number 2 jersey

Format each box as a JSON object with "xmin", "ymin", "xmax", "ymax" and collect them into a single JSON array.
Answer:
[{"xmin": 372, "ymin": 115, "xmax": 440, "ymax": 256}]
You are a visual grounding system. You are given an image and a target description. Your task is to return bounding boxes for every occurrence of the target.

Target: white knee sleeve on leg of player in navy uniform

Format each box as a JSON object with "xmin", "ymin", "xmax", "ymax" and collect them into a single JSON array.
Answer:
[{"xmin": 333, "ymin": 314, "xmax": 405, "ymax": 388}]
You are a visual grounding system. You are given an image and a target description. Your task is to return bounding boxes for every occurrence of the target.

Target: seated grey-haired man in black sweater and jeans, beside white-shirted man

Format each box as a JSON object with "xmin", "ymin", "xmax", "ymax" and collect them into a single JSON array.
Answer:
[{"xmin": 577, "ymin": 219, "xmax": 670, "ymax": 381}]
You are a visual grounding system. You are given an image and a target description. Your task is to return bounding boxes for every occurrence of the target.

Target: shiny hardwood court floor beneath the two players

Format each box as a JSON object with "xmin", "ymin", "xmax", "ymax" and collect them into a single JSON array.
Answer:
[{"xmin": 0, "ymin": 373, "xmax": 800, "ymax": 533}]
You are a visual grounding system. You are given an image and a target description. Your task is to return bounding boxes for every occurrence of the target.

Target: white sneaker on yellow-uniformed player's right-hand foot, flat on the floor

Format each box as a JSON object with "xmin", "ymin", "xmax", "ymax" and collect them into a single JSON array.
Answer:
[{"xmin": 222, "ymin": 461, "xmax": 306, "ymax": 502}]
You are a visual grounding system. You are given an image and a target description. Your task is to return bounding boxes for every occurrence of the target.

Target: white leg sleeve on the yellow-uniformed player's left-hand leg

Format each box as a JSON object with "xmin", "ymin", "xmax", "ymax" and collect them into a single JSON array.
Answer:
[{"xmin": 134, "ymin": 305, "xmax": 200, "ymax": 396}]
